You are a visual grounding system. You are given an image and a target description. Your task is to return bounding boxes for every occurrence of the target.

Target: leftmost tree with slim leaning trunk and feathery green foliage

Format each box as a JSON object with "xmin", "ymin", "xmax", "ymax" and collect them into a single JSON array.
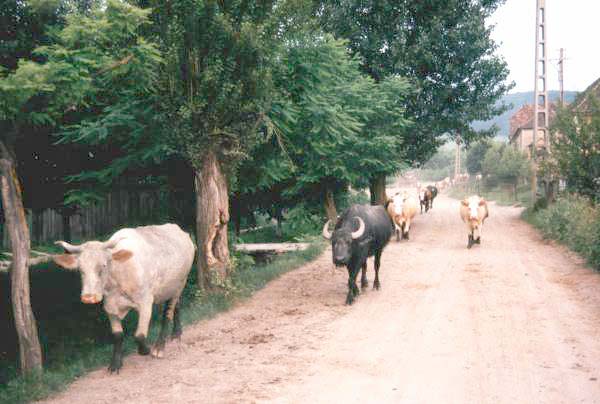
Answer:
[{"xmin": 0, "ymin": 1, "xmax": 158, "ymax": 373}]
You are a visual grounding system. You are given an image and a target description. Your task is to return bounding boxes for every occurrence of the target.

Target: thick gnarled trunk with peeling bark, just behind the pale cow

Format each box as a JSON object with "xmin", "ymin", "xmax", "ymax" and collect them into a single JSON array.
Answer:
[{"xmin": 195, "ymin": 151, "xmax": 230, "ymax": 289}]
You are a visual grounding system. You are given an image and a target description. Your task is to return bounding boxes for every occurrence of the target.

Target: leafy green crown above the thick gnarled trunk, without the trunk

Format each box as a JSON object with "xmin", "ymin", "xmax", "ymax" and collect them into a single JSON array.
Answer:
[{"xmin": 152, "ymin": 0, "xmax": 277, "ymax": 168}]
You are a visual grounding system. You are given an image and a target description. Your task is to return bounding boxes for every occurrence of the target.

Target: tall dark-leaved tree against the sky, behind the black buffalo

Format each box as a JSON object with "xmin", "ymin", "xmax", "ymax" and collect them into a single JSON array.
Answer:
[{"xmin": 315, "ymin": 0, "xmax": 510, "ymax": 202}]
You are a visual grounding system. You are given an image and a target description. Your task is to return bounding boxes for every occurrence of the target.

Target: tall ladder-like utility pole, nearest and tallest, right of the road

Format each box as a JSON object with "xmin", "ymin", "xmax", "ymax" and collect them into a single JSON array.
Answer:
[{"xmin": 531, "ymin": 0, "xmax": 549, "ymax": 203}]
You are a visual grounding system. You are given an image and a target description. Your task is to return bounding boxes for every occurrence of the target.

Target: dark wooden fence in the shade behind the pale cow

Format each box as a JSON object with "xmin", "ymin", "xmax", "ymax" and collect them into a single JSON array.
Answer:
[{"xmin": 1, "ymin": 188, "xmax": 167, "ymax": 250}]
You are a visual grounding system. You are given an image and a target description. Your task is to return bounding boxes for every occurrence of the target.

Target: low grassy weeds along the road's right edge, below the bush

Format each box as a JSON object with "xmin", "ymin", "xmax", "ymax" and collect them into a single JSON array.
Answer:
[{"xmin": 523, "ymin": 194, "xmax": 600, "ymax": 271}]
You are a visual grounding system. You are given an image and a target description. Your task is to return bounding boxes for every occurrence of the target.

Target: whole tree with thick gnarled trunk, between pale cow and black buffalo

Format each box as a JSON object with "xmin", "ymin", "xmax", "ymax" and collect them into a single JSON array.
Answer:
[{"xmin": 140, "ymin": 0, "xmax": 276, "ymax": 288}]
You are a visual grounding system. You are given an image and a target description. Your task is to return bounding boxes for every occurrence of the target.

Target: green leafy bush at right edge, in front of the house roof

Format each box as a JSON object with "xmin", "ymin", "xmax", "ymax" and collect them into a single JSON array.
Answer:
[{"xmin": 542, "ymin": 95, "xmax": 600, "ymax": 202}]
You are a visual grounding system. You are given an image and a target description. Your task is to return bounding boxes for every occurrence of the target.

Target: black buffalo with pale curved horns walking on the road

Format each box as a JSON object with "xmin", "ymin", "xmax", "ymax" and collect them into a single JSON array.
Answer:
[{"xmin": 323, "ymin": 205, "xmax": 394, "ymax": 304}]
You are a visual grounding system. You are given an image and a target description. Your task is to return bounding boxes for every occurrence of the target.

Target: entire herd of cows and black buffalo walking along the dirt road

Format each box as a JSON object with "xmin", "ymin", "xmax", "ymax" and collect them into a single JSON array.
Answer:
[{"xmin": 47, "ymin": 183, "xmax": 488, "ymax": 373}]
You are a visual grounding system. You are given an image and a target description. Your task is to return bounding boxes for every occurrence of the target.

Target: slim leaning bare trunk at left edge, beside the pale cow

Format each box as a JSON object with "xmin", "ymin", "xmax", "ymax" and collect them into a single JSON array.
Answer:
[{"xmin": 0, "ymin": 142, "xmax": 42, "ymax": 374}]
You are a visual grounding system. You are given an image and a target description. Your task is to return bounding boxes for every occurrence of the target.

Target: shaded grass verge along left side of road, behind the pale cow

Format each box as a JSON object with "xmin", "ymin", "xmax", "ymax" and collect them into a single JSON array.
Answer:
[{"xmin": 0, "ymin": 237, "xmax": 326, "ymax": 403}]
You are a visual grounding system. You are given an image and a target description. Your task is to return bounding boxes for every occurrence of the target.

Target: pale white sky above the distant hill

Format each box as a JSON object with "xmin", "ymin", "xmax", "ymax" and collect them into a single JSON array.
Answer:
[{"xmin": 488, "ymin": 0, "xmax": 600, "ymax": 92}]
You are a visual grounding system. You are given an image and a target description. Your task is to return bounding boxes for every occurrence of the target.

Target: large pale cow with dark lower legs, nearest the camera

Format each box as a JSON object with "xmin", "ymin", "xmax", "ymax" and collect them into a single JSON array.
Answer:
[{"xmin": 54, "ymin": 224, "xmax": 195, "ymax": 372}]
